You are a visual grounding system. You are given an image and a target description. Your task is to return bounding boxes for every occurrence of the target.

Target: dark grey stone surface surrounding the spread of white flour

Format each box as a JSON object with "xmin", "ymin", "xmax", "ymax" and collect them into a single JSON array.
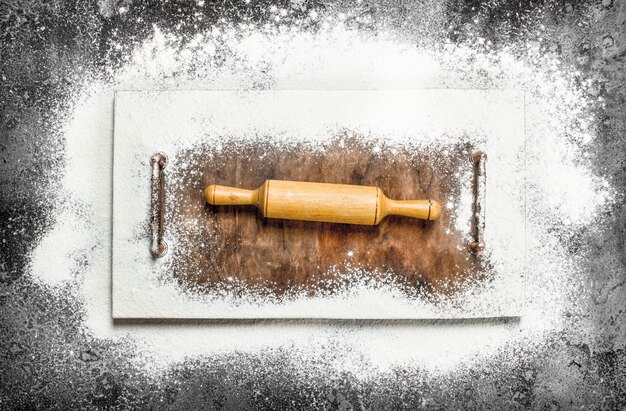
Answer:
[{"xmin": 0, "ymin": 0, "xmax": 626, "ymax": 409}]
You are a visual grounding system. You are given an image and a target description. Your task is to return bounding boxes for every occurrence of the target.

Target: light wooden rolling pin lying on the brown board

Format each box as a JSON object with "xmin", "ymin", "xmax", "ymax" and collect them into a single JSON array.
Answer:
[{"xmin": 204, "ymin": 180, "xmax": 441, "ymax": 225}]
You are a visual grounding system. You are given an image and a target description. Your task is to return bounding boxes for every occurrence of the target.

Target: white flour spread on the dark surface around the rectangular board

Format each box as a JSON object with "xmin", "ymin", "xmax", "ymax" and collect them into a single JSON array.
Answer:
[{"xmin": 31, "ymin": 13, "xmax": 612, "ymax": 378}]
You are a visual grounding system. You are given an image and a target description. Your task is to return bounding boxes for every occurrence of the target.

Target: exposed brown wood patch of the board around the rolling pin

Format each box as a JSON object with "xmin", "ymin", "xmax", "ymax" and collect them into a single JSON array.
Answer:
[{"xmin": 168, "ymin": 137, "xmax": 482, "ymax": 296}]
